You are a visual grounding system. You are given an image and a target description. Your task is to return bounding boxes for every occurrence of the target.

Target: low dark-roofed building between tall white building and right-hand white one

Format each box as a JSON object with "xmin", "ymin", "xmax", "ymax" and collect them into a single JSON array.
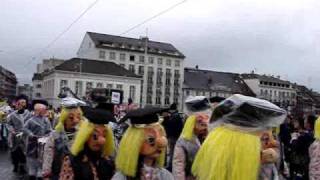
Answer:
[{"xmin": 182, "ymin": 67, "xmax": 255, "ymax": 110}]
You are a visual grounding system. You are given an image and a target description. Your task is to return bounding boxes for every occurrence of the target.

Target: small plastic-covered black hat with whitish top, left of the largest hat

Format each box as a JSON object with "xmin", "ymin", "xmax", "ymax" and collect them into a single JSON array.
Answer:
[{"xmin": 185, "ymin": 96, "xmax": 211, "ymax": 112}]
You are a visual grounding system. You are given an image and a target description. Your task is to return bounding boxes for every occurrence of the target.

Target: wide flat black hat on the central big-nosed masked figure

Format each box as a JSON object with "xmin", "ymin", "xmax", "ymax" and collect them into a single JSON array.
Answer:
[{"xmin": 119, "ymin": 107, "xmax": 168, "ymax": 125}]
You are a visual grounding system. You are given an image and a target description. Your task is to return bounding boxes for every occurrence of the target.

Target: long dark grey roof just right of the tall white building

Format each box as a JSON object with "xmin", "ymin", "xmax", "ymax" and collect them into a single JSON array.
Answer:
[{"xmin": 184, "ymin": 68, "xmax": 255, "ymax": 96}]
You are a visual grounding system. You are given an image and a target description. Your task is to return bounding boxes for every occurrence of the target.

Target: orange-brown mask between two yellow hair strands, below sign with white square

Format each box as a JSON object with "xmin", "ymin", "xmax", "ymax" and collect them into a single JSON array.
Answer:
[{"xmin": 87, "ymin": 125, "xmax": 107, "ymax": 152}]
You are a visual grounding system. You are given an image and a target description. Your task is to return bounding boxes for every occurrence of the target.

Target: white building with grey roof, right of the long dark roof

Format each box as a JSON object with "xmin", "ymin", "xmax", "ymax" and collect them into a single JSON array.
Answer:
[{"xmin": 241, "ymin": 73, "xmax": 296, "ymax": 109}]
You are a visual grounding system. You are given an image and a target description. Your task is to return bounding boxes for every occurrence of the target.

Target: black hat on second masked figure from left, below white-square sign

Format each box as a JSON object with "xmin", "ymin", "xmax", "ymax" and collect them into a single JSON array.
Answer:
[{"xmin": 81, "ymin": 106, "xmax": 116, "ymax": 124}]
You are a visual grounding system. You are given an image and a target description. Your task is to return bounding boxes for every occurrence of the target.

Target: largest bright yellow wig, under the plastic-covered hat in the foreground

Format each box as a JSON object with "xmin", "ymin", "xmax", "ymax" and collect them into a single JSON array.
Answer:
[{"xmin": 192, "ymin": 126, "xmax": 261, "ymax": 180}]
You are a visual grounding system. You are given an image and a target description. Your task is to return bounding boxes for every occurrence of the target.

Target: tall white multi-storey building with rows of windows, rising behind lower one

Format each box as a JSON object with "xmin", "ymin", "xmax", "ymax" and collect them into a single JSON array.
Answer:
[{"xmin": 77, "ymin": 32, "xmax": 185, "ymax": 108}]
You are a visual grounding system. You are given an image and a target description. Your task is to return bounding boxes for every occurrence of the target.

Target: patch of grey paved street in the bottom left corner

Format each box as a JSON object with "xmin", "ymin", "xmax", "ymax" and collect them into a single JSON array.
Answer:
[{"xmin": 0, "ymin": 151, "xmax": 22, "ymax": 180}]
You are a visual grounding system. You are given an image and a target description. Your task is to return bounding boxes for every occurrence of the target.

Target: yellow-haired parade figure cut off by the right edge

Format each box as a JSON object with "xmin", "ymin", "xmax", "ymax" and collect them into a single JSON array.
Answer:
[{"xmin": 309, "ymin": 117, "xmax": 320, "ymax": 180}]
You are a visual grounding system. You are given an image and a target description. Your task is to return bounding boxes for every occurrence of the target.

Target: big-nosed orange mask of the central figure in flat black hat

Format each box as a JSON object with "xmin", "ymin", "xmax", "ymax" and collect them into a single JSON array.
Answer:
[{"xmin": 140, "ymin": 125, "xmax": 168, "ymax": 158}]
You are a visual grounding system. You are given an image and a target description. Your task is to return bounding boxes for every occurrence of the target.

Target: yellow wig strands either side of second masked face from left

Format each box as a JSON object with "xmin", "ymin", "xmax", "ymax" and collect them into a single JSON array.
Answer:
[{"xmin": 71, "ymin": 120, "xmax": 115, "ymax": 156}]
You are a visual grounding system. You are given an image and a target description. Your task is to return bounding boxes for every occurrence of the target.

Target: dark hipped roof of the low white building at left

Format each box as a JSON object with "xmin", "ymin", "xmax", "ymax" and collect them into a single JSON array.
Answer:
[{"xmin": 54, "ymin": 58, "xmax": 141, "ymax": 78}]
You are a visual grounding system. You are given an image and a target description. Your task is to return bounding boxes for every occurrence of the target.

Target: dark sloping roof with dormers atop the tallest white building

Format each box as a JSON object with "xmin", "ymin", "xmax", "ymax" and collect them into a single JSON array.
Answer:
[{"xmin": 87, "ymin": 32, "xmax": 185, "ymax": 58}]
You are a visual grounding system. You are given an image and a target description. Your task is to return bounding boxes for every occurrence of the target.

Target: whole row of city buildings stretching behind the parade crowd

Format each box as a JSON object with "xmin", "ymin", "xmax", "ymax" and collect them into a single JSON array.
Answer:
[{"xmin": 2, "ymin": 32, "xmax": 320, "ymax": 114}]
